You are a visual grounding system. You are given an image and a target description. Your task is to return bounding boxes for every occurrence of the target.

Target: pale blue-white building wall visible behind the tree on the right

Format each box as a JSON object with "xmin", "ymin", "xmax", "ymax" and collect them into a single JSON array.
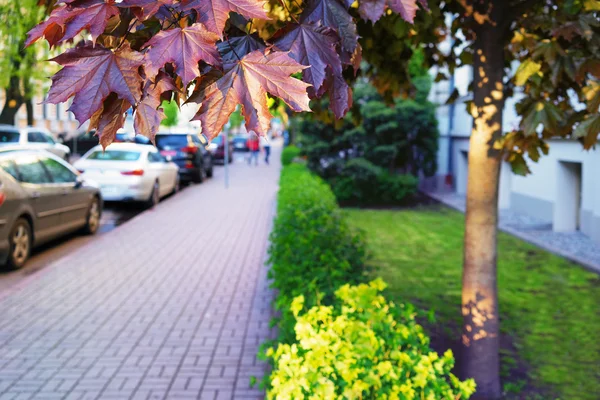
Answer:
[{"xmin": 428, "ymin": 67, "xmax": 600, "ymax": 243}]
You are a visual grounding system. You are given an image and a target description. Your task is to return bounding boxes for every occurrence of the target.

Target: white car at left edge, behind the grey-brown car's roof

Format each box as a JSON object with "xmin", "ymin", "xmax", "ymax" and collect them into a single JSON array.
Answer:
[{"xmin": 0, "ymin": 125, "xmax": 71, "ymax": 161}]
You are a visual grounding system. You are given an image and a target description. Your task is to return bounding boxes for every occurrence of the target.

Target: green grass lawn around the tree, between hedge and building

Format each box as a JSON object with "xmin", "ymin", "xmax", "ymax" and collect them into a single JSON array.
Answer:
[{"xmin": 346, "ymin": 207, "xmax": 600, "ymax": 399}]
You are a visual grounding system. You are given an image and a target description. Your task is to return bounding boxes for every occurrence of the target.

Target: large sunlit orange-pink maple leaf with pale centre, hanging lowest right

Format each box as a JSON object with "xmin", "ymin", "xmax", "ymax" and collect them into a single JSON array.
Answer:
[{"xmin": 189, "ymin": 50, "xmax": 310, "ymax": 140}]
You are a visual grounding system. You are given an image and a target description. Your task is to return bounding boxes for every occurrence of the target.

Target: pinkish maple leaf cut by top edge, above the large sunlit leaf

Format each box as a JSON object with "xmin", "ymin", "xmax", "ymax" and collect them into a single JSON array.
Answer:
[{"xmin": 181, "ymin": 0, "xmax": 268, "ymax": 38}]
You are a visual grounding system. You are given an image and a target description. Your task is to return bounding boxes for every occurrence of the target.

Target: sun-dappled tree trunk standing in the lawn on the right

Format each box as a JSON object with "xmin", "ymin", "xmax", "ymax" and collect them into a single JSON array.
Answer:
[{"xmin": 461, "ymin": 0, "xmax": 505, "ymax": 399}]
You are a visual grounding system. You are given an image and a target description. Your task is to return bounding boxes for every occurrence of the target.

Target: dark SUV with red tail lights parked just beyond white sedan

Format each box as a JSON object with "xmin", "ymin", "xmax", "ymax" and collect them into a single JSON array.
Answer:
[{"xmin": 156, "ymin": 133, "xmax": 213, "ymax": 183}]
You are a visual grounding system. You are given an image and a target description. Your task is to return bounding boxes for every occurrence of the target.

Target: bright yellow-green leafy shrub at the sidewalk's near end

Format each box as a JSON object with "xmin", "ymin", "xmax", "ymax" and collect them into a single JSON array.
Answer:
[{"xmin": 267, "ymin": 280, "xmax": 475, "ymax": 400}]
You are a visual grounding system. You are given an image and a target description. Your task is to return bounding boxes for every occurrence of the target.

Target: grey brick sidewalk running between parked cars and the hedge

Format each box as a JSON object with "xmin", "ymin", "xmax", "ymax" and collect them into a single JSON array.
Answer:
[{"xmin": 0, "ymin": 145, "xmax": 279, "ymax": 399}]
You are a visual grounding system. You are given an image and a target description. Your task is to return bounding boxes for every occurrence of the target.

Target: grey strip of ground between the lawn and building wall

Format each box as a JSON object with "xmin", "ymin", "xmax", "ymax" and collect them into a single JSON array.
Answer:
[{"xmin": 429, "ymin": 193, "xmax": 600, "ymax": 273}]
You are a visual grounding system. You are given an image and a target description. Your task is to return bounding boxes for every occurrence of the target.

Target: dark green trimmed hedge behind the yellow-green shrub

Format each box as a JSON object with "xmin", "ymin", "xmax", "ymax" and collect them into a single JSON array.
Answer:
[{"xmin": 269, "ymin": 164, "xmax": 366, "ymax": 343}]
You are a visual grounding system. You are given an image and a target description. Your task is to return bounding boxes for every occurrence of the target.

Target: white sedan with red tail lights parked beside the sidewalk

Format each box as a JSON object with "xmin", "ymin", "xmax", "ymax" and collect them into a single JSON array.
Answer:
[{"xmin": 74, "ymin": 143, "xmax": 179, "ymax": 206}]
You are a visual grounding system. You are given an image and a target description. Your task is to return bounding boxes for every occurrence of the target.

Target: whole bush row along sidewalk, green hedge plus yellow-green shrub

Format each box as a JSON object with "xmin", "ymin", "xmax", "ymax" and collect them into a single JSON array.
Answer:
[{"xmin": 266, "ymin": 164, "xmax": 474, "ymax": 399}]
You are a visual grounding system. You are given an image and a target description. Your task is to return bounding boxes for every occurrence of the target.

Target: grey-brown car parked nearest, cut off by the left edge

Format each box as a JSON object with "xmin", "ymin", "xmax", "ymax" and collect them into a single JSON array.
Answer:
[{"xmin": 0, "ymin": 149, "xmax": 102, "ymax": 268}]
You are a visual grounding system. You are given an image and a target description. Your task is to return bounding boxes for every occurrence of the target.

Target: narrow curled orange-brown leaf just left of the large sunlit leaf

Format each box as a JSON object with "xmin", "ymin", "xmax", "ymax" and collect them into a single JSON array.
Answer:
[{"xmin": 133, "ymin": 73, "xmax": 177, "ymax": 141}]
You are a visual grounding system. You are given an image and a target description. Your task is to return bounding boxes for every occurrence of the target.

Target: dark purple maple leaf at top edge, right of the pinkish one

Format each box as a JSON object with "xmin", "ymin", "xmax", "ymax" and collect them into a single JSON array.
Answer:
[{"xmin": 301, "ymin": 0, "xmax": 358, "ymax": 53}]
